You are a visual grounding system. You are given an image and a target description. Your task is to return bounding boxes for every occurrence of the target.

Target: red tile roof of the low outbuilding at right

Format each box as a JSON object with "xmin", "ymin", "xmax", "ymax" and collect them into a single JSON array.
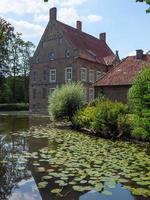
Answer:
[{"xmin": 94, "ymin": 54, "xmax": 150, "ymax": 86}]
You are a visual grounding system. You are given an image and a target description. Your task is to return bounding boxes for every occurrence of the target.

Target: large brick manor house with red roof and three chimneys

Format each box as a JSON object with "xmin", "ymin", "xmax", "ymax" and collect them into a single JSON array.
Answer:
[{"xmin": 29, "ymin": 8, "xmax": 119, "ymax": 114}]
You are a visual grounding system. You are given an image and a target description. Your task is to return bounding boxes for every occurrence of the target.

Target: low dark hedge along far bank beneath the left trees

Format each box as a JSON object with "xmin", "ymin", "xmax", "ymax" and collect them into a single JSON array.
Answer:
[{"xmin": 0, "ymin": 103, "xmax": 29, "ymax": 111}]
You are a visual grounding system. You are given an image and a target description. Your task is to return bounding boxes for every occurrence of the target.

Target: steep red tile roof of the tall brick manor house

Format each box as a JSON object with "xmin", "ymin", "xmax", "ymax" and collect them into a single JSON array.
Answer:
[{"xmin": 58, "ymin": 21, "xmax": 115, "ymax": 64}]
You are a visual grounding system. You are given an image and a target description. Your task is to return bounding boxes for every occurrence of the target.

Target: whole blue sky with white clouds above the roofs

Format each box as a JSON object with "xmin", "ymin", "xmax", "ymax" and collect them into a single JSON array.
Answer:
[{"xmin": 0, "ymin": 0, "xmax": 150, "ymax": 58}]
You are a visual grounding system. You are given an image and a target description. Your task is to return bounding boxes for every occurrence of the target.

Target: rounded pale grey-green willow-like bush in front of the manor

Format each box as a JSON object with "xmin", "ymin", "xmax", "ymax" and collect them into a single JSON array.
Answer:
[{"xmin": 48, "ymin": 82, "xmax": 84, "ymax": 121}]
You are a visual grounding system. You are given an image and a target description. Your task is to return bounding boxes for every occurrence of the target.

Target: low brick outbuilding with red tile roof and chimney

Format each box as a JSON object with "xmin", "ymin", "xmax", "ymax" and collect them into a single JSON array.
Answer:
[{"xmin": 94, "ymin": 50, "xmax": 150, "ymax": 102}]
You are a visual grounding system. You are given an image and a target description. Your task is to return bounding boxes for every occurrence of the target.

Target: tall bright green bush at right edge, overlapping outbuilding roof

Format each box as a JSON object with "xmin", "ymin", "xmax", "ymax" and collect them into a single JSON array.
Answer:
[{"xmin": 128, "ymin": 66, "xmax": 150, "ymax": 139}]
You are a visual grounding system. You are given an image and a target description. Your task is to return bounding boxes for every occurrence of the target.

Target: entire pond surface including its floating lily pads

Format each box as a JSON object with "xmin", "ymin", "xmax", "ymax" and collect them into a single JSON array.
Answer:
[{"xmin": 0, "ymin": 115, "xmax": 150, "ymax": 200}]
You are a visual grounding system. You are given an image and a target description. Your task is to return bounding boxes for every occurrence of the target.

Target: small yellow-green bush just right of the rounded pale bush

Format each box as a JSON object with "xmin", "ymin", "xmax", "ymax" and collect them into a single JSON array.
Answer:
[{"xmin": 73, "ymin": 106, "xmax": 95, "ymax": 129}]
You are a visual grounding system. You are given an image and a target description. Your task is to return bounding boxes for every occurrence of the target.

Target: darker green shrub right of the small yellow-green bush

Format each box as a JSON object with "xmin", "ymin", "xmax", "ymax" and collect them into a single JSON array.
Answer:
[{"xmin": 92, "ymin": 100, "xmax": 127, "ymax": 138}]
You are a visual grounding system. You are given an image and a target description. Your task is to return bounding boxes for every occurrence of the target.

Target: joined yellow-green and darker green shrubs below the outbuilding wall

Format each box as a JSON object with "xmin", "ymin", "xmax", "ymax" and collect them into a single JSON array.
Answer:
[{"xmin": 73, "ymin": 100, "xmax": 130, "ymax": 138}]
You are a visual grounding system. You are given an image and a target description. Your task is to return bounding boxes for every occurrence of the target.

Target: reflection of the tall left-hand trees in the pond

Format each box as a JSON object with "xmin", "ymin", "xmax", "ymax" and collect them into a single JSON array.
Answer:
[{"xmin": 0, "ymin": 135, "xmax": 31, "ymax": 199}]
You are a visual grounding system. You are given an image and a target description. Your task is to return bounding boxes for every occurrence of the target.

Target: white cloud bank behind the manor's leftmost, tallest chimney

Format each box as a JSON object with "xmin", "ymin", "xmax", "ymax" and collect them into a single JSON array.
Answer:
[{"xmin": 0, "ymin": 0, "xmax": 102, "ymax": 41}]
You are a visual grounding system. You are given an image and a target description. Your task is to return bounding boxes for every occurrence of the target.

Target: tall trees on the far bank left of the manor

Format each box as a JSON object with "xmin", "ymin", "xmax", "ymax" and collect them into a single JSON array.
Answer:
[{"xmin": 0, "ymin": 18, "xmax": 34, "ymax": 103}]
